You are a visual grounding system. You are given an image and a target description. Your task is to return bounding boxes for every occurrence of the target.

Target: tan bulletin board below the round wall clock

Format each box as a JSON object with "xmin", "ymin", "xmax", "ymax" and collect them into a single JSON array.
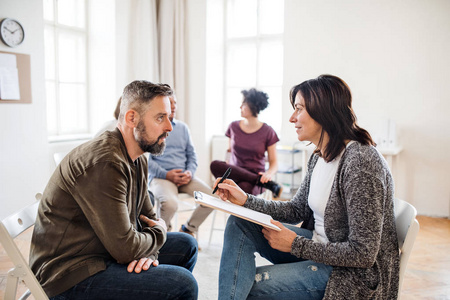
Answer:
[{"xmin": 0, "ymin": 51, "xmax": 31, "ymax": 104}]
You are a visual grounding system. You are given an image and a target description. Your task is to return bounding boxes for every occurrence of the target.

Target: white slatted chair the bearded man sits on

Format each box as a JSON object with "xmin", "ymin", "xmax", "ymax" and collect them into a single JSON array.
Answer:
[{"xmin": 0, "ymin": 194, "xmax": 48, "ymax": 300}]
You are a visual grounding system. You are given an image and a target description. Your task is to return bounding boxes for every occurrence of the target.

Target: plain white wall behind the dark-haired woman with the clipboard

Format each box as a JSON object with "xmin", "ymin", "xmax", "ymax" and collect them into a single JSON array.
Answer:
[{"xmin": 281, "ymin": 0, "xmax": 450, "ymax": 216}]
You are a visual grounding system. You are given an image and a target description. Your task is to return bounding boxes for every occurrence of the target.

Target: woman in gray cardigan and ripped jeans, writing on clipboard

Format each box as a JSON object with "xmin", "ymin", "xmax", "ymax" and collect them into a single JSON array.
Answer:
[{"xmin": 216, "ymin": 75, "xmax": 399, "ymax": 299}]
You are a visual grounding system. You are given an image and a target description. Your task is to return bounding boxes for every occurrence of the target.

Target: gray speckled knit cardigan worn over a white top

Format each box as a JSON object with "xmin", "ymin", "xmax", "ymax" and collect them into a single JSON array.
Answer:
[{"xmin": 245, "ymin": 143, "xmax": 399, "ymax": 299}]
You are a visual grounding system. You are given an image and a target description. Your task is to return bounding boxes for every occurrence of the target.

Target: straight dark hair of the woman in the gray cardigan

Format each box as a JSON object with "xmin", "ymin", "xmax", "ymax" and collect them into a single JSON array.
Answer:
[{"xmin": 289, "ymin": 75, "xmax": 376, "ymax": 162}]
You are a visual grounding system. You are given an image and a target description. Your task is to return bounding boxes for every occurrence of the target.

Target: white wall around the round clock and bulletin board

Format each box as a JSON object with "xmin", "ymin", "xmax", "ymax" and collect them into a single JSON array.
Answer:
[{"xmin": 0, "ymin": 0, "xmax": 49, "ymax": 218}]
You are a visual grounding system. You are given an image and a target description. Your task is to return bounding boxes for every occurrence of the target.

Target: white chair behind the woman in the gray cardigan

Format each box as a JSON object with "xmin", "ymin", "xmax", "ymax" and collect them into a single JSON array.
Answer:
[{"xmin": 394, "ymin": 199, "xmax": 419, "ymax": 298}]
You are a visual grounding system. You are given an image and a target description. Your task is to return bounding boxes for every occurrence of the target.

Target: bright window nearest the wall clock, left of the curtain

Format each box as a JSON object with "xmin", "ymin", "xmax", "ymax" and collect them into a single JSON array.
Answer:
[{"xmin": 43, "ymin": 0, "xmax": 89, "ymax": 136}]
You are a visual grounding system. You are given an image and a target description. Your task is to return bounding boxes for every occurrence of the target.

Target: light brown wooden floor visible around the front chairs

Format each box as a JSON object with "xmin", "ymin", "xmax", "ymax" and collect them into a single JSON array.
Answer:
[{"xmin": 0, "ymin": 216, "xmax": 450, "ymax": 300}]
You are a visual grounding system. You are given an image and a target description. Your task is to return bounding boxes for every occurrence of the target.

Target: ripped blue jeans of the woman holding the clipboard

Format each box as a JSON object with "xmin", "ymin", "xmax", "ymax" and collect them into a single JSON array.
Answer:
[{"xmin": 219, "ymin": 216, "xmax": 333, "ymax": 300}]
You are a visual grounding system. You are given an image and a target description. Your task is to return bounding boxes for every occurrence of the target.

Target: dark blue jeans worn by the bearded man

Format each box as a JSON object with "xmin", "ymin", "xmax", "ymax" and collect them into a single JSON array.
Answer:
[{"xmin": 51, "ymin": 232, "xmax": 198, "ymax": 300}]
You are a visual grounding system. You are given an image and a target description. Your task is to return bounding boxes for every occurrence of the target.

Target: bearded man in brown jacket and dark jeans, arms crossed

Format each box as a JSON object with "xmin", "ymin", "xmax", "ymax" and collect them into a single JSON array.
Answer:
[{"xmin": 30, "ymin": 81, "xmax": 198, "ymax": 299}]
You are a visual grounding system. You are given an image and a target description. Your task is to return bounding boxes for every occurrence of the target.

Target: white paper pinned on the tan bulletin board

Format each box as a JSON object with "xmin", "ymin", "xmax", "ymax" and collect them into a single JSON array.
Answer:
[{"xmin": 0, "ymin": 53, "xmax": 20, "ymax": 100}]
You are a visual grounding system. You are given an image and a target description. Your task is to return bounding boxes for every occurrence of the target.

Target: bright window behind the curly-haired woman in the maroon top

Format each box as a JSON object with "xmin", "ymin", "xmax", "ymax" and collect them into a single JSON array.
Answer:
[{"xmin": 224, "ymin": 0, "xmax": 284, "ymax": 132}]
